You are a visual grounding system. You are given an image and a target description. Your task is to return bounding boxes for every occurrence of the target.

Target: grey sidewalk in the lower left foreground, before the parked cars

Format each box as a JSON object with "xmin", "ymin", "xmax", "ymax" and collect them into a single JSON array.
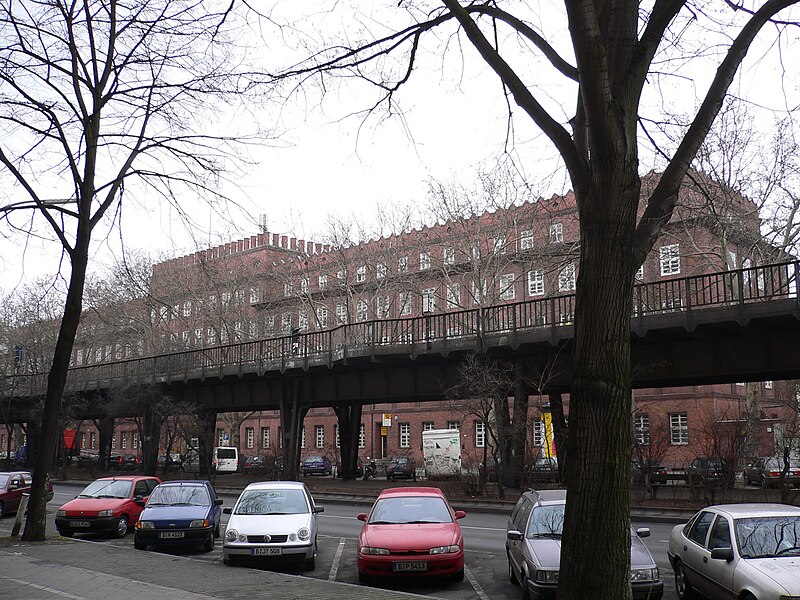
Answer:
[{"xmin": 0, "ymin": 540, "xmax": 427, "ymax": 600}]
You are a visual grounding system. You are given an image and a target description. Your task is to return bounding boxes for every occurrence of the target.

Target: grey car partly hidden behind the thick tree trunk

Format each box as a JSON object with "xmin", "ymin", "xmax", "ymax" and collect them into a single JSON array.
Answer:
[{"xmin": 506, "ymin": 490, "xmax": 664, "ymax": 600}]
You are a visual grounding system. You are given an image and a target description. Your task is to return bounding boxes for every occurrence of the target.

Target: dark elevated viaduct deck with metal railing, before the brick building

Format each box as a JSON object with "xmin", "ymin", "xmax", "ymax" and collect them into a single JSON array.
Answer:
[{"xmin": 6, "ymin": 261, "xmax": 800, "ymax": 410}]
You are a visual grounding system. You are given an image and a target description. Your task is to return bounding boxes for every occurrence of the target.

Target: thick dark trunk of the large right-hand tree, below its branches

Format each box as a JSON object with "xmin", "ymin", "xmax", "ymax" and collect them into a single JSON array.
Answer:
[{"xmin": 558, "ymin": 171, "xmax": 640, "ymax": 600}]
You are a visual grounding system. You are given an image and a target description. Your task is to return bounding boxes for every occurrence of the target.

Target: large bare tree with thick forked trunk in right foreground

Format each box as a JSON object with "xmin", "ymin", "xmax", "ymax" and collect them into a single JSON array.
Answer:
[{"xmin": 268, "ymin": 0, "xmax": 797, "ymax": 600}]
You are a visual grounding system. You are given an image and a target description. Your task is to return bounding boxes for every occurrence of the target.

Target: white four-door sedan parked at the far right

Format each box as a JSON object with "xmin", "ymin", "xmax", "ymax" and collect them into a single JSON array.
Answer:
[{"xmin": 667, "ymin": 503, "xmax": 800, "ymax": 600}]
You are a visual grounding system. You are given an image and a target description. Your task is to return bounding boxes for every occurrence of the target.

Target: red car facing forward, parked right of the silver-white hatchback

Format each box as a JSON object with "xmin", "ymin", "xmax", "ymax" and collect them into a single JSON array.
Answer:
[{"xmin": 358, "ymin": 487, "xmax": 467, "ymax": 583}]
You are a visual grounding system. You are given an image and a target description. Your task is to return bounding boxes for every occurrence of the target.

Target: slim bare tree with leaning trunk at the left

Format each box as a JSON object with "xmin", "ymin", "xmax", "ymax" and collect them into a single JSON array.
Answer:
[{"xmin": 0, "ymin": 0, "xmax": 260, "ymax": 540}]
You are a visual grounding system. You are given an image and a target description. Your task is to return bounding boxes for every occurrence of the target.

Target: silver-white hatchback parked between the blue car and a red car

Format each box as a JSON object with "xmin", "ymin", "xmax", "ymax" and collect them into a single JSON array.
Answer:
[{"xmin": 222, "ymin": 481, "xmax": 323, "ymax": 570}]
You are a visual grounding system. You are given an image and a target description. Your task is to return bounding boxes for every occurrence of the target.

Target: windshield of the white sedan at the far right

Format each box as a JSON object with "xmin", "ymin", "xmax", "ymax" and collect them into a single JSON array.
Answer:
[{"xmin": 734, "ymin": 515, "xmax": 800, "ymax": 558}]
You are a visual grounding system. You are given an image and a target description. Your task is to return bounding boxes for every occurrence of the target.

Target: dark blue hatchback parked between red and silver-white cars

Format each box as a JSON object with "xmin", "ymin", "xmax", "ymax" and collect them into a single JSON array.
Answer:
[{"xmin": 133, "ymin": 481, "xmax": 222, "ymax": 552}]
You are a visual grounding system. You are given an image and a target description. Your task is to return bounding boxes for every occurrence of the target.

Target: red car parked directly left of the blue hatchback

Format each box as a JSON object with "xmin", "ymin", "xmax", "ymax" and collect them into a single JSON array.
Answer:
[{"xmin": 56, "ymin": 475, "xmax": 161, "ymax": 537}]
